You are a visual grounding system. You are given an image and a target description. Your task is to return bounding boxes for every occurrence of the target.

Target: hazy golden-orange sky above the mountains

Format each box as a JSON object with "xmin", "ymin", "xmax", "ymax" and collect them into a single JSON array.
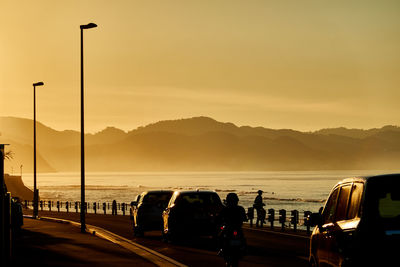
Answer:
[{"xmin": 0, "ymin": 0, "xmax": 400, "ymax": 132}]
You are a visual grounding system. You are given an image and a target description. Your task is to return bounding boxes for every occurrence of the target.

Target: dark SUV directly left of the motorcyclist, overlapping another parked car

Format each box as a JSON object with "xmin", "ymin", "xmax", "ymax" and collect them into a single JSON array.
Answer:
[{"xmin": 163, "ymin": 190, "xmax": 223, "ymax": 240}]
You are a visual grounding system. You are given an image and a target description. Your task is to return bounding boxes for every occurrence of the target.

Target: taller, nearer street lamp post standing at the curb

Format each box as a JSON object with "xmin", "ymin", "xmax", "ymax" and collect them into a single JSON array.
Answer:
[{"xmin": 80, "ymin": 23, "xmax": 97, "ymax": 233}]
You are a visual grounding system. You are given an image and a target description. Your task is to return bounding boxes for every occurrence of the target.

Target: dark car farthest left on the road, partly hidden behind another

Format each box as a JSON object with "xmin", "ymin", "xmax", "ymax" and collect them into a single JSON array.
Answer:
[{"xmin": 131, "ymin": 190, "xmax": 174, "ymax": 236}]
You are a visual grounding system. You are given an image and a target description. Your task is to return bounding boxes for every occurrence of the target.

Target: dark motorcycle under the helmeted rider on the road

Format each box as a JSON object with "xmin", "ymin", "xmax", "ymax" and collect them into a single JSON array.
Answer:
[{"xmin": 218, "ymin": 226, "xmax": 247, "ymax": 267}]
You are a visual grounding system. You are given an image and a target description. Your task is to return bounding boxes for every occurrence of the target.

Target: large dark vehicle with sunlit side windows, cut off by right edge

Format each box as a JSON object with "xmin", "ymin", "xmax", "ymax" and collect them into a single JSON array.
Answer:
[{"xmin": 309, "ymin": 174, "xmax": 400, "ymax": 266}]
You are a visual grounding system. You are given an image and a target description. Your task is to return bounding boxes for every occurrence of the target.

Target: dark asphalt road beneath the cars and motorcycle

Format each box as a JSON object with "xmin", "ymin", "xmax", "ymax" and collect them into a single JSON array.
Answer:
[{"xmin": 25, "ymin": 210, "xmax": 309, "ymax": 267}]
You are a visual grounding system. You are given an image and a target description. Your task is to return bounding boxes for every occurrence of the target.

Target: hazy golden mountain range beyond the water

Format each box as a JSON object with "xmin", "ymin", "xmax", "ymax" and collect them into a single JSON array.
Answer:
[{"xmin": 0, "ymin": 117, "xmax": 400, "ymax": 171}]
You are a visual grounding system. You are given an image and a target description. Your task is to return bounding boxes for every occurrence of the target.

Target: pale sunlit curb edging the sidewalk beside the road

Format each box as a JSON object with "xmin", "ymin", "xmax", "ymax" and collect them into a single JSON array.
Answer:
[{"xmin": 24, "ymin": 215, "xmax": 187, "ymax": 267}]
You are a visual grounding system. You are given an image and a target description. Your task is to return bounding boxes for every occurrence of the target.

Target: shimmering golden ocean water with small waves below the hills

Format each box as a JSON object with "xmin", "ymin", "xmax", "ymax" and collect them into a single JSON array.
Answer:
[{"xmin": 22, "ymin": 170, "xmax": 393, "ymax": 213}]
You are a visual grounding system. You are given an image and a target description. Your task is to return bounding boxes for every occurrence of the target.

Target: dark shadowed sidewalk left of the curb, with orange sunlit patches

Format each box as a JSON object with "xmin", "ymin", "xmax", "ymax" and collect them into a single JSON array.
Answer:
[{"xmin": 11, "ymin": 219, "xmax": 156, "ymax": 267}]
